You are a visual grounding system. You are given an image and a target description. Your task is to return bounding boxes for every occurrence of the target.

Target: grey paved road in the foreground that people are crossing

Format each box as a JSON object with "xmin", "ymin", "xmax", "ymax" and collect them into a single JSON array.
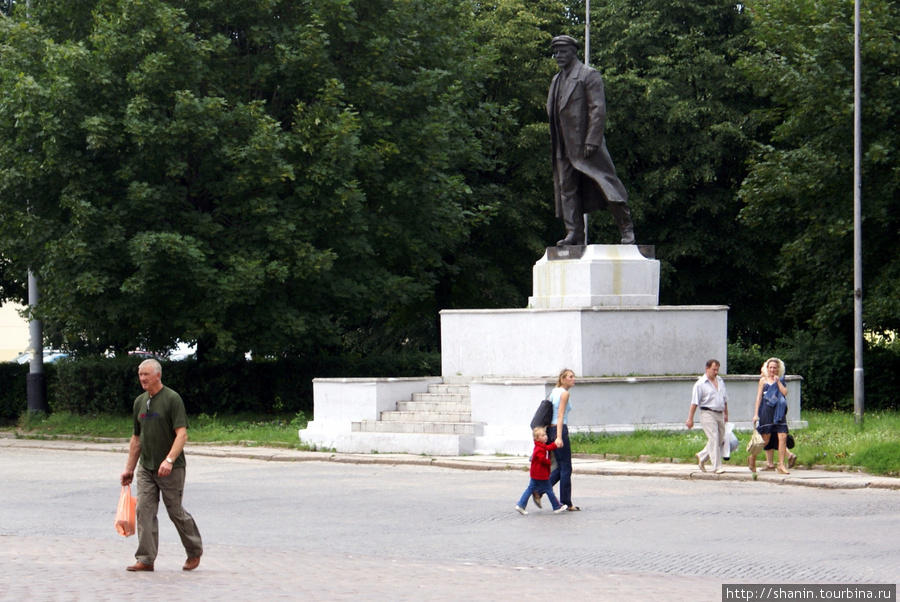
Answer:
[{"xmin": 0, "ymin": 447, "xmax": 900, "ymax": 601}]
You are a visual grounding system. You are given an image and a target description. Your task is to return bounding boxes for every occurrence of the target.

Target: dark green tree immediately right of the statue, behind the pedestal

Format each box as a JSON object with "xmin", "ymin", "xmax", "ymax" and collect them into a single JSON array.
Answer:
[{"xmin": 591, "ymin": 0, "xmax": 779, "ymax": 341}]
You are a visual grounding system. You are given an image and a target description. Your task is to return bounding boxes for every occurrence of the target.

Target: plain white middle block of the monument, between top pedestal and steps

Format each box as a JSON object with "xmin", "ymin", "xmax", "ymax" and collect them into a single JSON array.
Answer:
[{"xmin": 441, "ymin": 305, "xmax": 728, "ymax": 378}]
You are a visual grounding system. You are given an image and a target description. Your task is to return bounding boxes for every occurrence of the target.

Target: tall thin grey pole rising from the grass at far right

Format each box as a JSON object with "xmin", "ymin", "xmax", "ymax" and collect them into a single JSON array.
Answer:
[{"xmin": 853, "ymin": 0, "xmax": 865, "ymax": 424}]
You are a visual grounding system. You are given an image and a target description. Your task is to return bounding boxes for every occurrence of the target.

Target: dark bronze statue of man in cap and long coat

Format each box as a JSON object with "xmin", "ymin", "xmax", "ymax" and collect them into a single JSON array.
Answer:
[{"xmin": 547, "ymin": 36, "xmax": 634, "ymax": 246}]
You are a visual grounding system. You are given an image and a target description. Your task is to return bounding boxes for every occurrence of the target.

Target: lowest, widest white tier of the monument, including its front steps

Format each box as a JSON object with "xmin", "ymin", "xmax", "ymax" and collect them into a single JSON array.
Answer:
[{"xmin": 298, "ymin": 375, "xmax": 807, "ymax": 456}]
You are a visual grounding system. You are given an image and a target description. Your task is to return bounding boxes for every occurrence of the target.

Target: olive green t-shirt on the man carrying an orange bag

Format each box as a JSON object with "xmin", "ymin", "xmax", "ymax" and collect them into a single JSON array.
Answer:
[{"xmin": 134, "ymin": 386, "xmax": 188, "ymax": 471}]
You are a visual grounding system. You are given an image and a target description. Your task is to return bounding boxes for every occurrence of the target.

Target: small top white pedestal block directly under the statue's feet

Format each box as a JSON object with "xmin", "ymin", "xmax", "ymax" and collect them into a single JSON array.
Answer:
[{"xmin": 528, "ymin": 245, "xmax": 659, "ymax": 309}]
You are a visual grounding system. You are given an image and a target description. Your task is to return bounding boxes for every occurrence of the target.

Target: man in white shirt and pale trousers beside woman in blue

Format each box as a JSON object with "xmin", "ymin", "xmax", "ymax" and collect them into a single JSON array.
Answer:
[{"xmin": 685, "ymin": 360, "xmax": 728, "ymax": 474}]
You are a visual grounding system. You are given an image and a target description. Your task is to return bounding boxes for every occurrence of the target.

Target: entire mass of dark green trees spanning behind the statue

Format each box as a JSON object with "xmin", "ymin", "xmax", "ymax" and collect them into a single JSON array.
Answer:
[{"xmin": 0, "ymin": 0, "xmax": 900, "ymax": 408}]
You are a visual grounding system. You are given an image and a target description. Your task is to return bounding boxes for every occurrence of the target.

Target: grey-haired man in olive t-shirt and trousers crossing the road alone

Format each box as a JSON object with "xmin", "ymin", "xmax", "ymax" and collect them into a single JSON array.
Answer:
[{"xmin": 121, "ymin": 359, "xmax": 203, "ymax": 571}]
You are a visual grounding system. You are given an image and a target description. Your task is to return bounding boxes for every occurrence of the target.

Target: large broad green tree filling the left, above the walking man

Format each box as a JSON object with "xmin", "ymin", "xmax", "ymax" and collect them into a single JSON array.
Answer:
[{"xmin": 0, "ymin": 0, "xmax": 495, "ymax": 354}]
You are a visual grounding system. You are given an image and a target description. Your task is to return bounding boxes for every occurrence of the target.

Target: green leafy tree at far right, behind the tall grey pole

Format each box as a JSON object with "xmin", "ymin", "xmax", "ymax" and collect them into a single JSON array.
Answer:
[{"xmin": 741, "ymin": 0, "xmax": 900, "ymax": 344}]
